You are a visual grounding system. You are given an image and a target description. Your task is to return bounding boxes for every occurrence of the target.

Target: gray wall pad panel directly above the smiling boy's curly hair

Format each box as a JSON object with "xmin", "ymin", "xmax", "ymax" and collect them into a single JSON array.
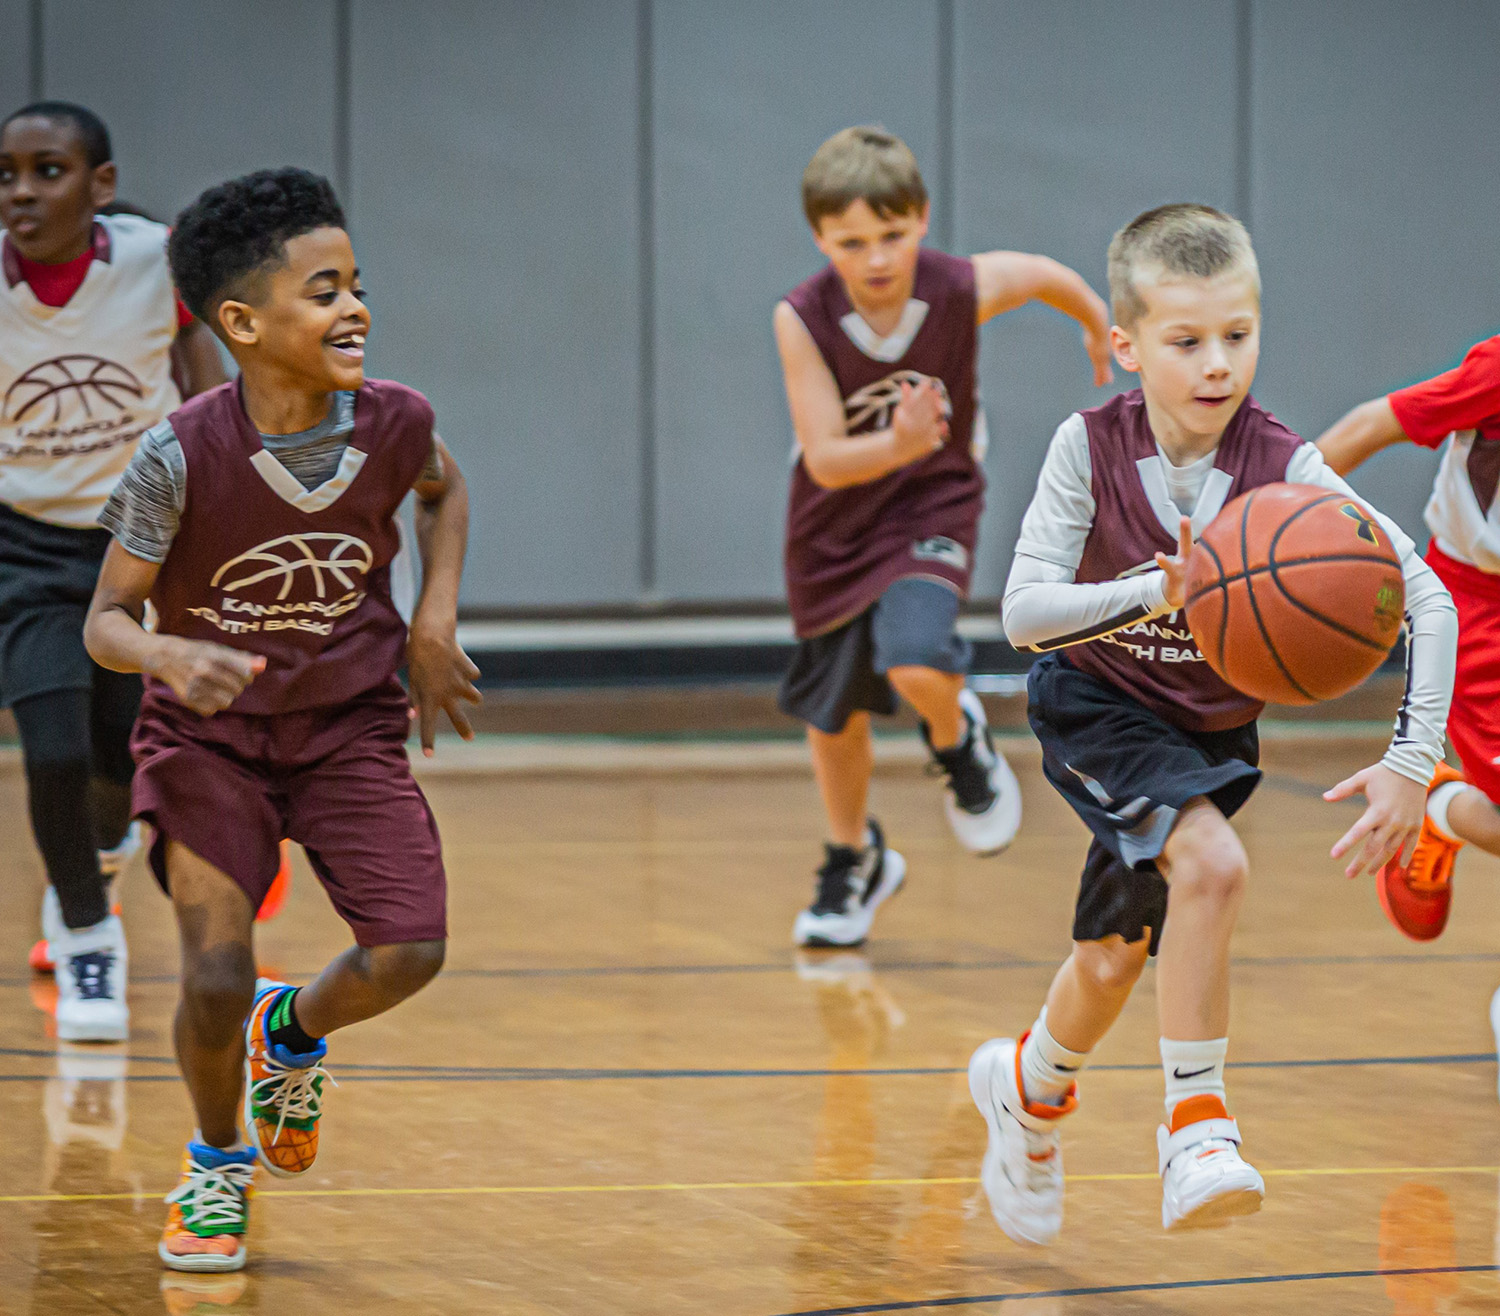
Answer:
[{"xmin": 44, "ymin": 0, "xmax": 335, "ymax": 219}]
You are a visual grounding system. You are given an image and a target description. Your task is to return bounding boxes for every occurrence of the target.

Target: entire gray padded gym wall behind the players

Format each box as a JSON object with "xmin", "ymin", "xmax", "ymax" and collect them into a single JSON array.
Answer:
[{"xmin": 0, "ymin": 0, "xmax": 1500, "ymax": 608}]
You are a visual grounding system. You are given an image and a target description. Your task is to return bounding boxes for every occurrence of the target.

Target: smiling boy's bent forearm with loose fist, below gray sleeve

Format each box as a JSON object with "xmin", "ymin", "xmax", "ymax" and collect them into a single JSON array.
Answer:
[{"xmin": 84, "ymin": 543, "xmax": 266, "ymax": 717}]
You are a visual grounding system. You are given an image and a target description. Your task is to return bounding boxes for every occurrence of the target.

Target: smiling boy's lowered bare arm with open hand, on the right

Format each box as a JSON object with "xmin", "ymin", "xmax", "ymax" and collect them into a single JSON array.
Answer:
[{"xmin": 407, "ymin": 435, "xmax": 483, "ymax": 758}]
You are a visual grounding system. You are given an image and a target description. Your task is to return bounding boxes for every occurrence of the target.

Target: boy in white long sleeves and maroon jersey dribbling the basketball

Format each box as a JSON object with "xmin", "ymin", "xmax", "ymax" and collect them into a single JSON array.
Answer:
[{"xmin": 969, "ymin": 206, "xmax": 1457, "ymax": 1242}]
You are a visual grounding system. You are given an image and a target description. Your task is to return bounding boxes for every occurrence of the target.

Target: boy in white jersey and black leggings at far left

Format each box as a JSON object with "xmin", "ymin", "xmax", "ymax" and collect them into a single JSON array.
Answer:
[{"xmin": 0, "ymin": 101, "xmax": 224, "ymax": 1041}]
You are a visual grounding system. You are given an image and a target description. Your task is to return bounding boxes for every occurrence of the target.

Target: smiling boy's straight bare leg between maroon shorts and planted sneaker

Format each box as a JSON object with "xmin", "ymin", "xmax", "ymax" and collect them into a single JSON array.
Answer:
[{"xmin": 167, "ymin": 840, "xmax": 255, "ymax": 1146}]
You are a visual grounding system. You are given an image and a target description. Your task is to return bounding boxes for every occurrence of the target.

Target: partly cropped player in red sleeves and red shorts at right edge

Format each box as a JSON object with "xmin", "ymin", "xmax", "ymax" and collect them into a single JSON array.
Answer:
[{"xmin": 1317, "ymin": 336, "xmax": 1500, "ymax": 942}]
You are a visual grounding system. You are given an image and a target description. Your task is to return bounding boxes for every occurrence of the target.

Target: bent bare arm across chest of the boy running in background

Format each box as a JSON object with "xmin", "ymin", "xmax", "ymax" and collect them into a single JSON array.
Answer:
[{"xmin": 773, "ymin": 302, "xmax": 948, "ymax": 489}]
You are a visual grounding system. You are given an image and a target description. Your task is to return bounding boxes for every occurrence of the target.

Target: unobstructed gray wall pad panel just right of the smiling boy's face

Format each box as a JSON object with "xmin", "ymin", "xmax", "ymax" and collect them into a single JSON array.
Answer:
[{"xmin": 351, "ymin": 0, "xmax": 642, "ymax": 605}]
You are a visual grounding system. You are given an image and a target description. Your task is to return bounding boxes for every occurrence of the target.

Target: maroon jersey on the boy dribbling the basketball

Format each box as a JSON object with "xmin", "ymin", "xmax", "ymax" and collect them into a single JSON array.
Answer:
[{"xmin": 1068, "ymin": 389, "xmax": 1302, "ymax": 731}]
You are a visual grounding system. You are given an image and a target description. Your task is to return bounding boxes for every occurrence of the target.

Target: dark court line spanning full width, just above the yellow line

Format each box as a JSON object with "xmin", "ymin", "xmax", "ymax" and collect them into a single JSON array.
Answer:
[{"xmin": 0, "ymin": 1047, "xmax": 1496, "ymax": 1083}]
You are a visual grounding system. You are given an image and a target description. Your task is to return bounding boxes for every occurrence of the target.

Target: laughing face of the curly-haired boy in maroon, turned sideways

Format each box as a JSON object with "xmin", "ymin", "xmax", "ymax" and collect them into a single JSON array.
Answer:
[{"xmin": 218, "ymin": 228, "xmax": 371, "ymax": 393}]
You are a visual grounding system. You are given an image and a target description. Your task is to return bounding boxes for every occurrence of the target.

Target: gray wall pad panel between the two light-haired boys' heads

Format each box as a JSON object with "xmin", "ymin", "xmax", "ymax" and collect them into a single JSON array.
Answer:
[{"xmin": 954, "ymin": 0, "xmax": 1236, "ymax": 597}]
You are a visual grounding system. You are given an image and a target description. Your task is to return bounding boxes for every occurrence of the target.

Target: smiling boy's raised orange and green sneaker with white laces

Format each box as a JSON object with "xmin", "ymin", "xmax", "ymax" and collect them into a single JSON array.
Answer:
[{"xmin": 245, "ymin": 978, "xmax": 333, "ymax": 1179}]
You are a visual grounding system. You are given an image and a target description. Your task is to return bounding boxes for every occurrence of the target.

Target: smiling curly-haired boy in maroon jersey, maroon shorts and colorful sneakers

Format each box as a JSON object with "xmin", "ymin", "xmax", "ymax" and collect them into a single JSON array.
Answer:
[{"xmin": 86, "ymin": 170, "xmax": 479, "ymax": 1271}]
